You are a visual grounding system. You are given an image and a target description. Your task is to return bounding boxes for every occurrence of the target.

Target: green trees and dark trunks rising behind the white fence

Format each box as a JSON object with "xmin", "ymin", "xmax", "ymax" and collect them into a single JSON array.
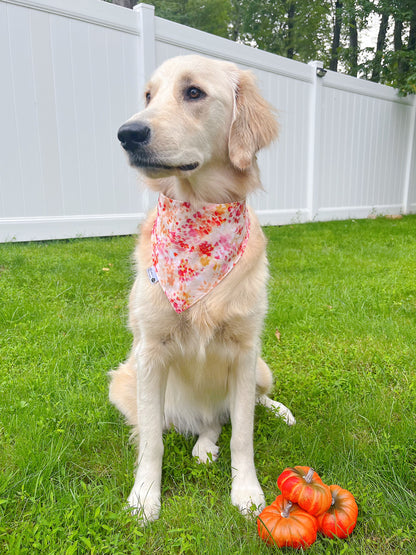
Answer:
[{"xmin": 106, "ymin": 0, "xmax": 416, "ymax": 95}]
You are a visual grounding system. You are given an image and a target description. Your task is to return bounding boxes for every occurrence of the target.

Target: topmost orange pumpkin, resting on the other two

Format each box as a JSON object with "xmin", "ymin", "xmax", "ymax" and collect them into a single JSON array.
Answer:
[{"xmin": 277, "ymin": 466, "xmax": 332, "ymax": 516}]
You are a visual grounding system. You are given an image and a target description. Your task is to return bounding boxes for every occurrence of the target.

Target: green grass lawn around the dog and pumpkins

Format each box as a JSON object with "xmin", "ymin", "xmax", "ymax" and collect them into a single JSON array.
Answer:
[{"xmin": 0, "ymin": 216, "xmax": 416, "ymax": 555}]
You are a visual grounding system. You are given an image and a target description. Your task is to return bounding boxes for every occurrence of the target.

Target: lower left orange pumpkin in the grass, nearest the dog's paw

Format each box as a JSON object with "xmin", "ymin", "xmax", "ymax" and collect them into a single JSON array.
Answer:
[{"xmin": 257, "ymin": 495, "xmax": 318, "ymax": 549}]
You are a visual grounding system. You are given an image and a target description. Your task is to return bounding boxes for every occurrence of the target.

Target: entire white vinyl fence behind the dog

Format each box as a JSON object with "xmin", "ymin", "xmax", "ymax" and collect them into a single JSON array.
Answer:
[{"xmin": 0, "ymin": 0, "xmax": 416, "ymax": 241}]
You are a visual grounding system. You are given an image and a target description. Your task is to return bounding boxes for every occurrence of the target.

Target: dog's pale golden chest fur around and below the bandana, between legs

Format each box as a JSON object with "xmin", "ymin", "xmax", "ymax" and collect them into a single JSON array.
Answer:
[{"xmin": 130, "ymin": 205, "xmax": 267, "ymax": 433}]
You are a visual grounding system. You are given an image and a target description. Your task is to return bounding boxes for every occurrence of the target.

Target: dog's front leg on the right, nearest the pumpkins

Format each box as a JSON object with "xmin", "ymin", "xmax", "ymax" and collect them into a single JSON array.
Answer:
[{"xmin": 230, "ymin": 349, "xmax": 265, "ymax": 514}]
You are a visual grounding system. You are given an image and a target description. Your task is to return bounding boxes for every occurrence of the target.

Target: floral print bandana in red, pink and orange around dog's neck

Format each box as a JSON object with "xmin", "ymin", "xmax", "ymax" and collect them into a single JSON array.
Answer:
[{"xmin": 148, "ymin": 194, "xmax": 250, "ymax": 314}]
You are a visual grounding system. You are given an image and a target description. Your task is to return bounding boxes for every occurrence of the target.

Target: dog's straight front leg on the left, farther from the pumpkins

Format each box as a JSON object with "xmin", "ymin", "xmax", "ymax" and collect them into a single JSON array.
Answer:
[{"xmin": 128, "ymin": 339, "xmax": 168, "ymax": 523}]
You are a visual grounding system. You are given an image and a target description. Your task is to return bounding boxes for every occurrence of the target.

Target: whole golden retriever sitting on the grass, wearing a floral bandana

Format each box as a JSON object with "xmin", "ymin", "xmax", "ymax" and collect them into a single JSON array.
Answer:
[{"xmin": 110, "ymin": 55, "xmax": 295, "ymax": 523}]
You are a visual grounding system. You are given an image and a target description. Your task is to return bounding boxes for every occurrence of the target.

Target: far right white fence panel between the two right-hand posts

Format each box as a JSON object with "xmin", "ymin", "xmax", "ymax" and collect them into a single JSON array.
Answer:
[{"xmin": 317, "ymin": 72, "xmax": 413, "ymax": 219}]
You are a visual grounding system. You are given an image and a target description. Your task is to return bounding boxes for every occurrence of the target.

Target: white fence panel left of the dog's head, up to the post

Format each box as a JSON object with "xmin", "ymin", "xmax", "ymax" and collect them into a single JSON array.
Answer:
[{"xmin": 0, "ymin": 0, "xmax": 147, "ymax": 241}]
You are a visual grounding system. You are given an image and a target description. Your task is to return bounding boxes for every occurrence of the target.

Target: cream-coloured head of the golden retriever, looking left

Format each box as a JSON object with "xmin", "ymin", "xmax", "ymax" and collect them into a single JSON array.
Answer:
[{"xmin": 118, "ymin": 56, "xmax": 277, "ymax": 178}]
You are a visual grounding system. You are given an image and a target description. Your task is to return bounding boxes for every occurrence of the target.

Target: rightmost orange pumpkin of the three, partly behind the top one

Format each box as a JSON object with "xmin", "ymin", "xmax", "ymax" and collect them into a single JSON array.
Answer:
[{"xmin": 318, "ymin": 485, "xmax": 358, "ymax": 538}]
